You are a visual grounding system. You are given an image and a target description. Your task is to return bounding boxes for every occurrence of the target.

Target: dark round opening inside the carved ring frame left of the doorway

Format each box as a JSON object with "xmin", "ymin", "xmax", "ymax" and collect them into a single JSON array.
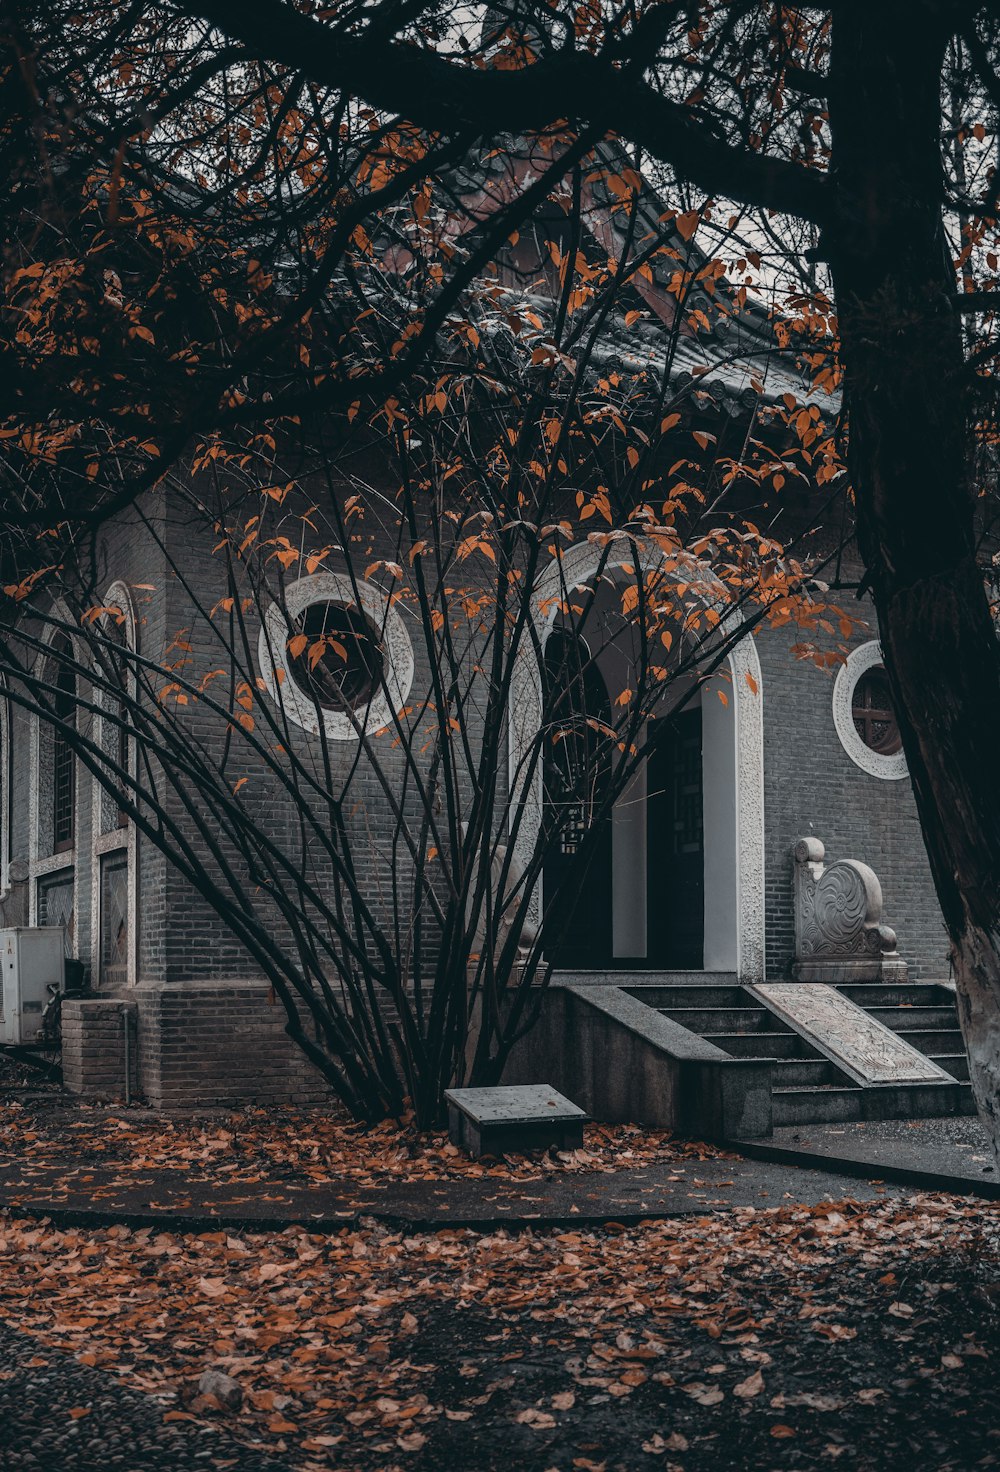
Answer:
[{"xmin": 289, "ymin": 604, "xmax": 383, "ymax": 711}]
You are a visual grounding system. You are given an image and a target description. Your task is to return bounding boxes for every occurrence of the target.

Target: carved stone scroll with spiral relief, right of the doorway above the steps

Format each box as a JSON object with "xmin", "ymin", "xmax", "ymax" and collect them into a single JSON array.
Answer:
[{"xmin": 792, "ymin": 838, "xmax": 906, "ymax": 986}]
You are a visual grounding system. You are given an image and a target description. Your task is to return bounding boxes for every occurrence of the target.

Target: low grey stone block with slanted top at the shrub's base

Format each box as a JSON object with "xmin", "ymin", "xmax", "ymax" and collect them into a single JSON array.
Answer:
[{"xmin": 445, "ymin": 1083, "xmax": 589, "ymax": 1158}]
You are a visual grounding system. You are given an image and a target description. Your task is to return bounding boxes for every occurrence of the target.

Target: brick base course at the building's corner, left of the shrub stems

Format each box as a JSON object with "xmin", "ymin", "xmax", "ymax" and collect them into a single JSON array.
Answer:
[{"xmin": 133, "ymin": 980, "xmax": 330, "ymax": 1108}]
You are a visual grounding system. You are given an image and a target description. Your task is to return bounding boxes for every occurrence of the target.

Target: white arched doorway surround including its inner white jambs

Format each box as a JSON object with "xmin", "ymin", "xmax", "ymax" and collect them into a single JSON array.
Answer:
[{"xmin": 510, "ymin": 540, "xmax": 764, "ymax": 982}]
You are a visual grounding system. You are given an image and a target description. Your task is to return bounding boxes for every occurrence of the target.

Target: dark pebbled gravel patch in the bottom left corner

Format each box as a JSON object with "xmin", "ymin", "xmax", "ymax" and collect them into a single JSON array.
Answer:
[{"xmin": 0, "ymin": 1325, "xmax": 289, "ymax": 1472}]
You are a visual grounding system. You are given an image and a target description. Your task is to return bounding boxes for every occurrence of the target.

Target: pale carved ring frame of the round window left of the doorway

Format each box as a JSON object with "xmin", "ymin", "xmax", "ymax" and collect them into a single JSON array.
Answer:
[{"xmin": 258, "ymin": 573, "xmax": 414, "ymax": 740}]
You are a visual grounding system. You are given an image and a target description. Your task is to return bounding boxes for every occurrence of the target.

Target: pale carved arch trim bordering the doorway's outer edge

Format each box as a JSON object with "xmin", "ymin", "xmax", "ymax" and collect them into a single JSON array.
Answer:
[{"xmin": 508, "ymin": 542, "xmax": 766, "ymax": 982}]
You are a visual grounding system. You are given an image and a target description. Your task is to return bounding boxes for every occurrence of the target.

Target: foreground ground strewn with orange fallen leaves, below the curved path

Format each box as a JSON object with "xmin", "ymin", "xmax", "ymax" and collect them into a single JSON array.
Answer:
[{"xmin": 0, "ymin": 1189, "xmax": 1000, "ymax": 1472}]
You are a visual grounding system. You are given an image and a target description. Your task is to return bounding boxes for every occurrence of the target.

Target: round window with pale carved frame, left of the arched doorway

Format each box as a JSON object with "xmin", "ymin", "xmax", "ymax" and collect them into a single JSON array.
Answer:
[{"xmin": 258, "ymin": 573, "xmax": 414, "ymax": 740}]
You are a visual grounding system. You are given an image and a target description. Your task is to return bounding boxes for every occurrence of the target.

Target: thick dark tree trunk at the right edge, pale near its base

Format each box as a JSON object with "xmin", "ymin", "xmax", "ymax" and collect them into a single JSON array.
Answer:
[{"xmin": 828, "ymin": 0, "xmax": 1000, "ymax": 1160}]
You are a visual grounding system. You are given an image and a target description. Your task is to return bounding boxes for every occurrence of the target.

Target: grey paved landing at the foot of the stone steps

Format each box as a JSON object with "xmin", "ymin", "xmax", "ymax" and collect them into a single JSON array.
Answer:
[{"xmin": 733, "ymin": 1116, "xmax": 1000, "ymax": 1201}]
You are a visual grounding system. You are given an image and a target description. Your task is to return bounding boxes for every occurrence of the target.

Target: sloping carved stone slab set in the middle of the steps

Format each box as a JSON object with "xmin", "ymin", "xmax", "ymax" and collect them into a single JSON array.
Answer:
[{"xmin": 750, "ymin": 982, "xmax": 954, "ymax": 1083}]
